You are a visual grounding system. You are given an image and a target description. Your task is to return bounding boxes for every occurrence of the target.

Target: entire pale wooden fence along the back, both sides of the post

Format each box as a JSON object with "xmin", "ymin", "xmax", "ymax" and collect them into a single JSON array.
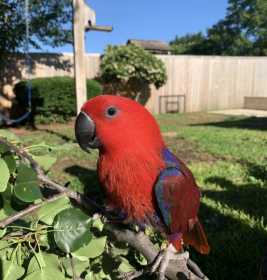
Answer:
[{"xmin": 5, "ymin": 54, "xmax": 267, "ymax": 113}]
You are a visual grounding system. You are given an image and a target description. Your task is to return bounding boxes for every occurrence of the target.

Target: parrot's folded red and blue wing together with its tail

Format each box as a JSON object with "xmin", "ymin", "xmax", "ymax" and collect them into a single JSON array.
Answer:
[{"xmin": 154, "ymin": 149, "xmax": 209, "ymax": 254}]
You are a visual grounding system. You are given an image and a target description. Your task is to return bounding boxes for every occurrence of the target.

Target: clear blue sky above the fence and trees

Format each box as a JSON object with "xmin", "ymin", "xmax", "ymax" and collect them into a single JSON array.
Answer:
[{"xmin": 44, "ymin": 0, "xmax": 227, "ymax": 53}]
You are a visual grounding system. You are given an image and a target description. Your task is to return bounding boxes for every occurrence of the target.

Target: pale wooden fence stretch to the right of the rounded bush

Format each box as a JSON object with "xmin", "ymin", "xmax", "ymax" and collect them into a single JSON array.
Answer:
[{"xmin": 148, "ymin": 56, "xmax": 267, "ymax": 112}]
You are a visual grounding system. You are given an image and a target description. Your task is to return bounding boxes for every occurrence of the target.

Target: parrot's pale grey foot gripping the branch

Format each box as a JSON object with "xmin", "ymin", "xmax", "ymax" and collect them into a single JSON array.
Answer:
[{"xmin": 150, "ymin": 244, "xmax": 189, "ymax": 280}]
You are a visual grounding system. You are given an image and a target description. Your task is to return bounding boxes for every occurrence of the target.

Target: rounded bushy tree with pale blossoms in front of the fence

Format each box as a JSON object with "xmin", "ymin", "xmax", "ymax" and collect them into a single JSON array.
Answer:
[{"xmin": 100, "ymin": 44, "xmax": 167, "ymax": 103}]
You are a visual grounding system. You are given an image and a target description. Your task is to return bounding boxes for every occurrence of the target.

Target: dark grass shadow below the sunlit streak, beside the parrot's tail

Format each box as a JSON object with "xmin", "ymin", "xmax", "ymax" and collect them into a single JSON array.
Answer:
[{"xmin": 197, "ymin": 202, "xmax": 267, "ymax": 280}]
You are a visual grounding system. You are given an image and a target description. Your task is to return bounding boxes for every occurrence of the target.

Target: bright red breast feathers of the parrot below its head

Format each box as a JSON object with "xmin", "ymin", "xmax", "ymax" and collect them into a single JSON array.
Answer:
[{"xmin": 98, "ymin": 147, "xmax": 164, "ymax": 222}]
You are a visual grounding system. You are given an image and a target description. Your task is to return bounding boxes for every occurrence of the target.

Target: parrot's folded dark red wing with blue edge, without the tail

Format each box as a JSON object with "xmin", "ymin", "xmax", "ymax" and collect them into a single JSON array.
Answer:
[{"xmin": 154, "ymin": 149, "xmax": 200, "ymax": 233}]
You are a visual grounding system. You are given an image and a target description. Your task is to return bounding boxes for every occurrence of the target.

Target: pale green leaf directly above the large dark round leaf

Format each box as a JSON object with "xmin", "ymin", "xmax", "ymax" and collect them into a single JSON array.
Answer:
[{"xmin": 37, "ymin": 197, "xmax": 71, "ymax": 225}]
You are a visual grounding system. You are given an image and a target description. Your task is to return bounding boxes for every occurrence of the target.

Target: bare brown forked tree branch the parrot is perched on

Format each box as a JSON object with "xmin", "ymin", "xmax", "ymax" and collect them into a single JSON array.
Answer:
[{"xmin": 0, "ymin": 138, "xmax": 208, "ymax": 280}]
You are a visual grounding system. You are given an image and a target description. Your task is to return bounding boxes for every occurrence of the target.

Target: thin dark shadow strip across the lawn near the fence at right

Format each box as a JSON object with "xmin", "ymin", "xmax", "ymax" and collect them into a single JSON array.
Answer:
[{"xmin": 191, "ymin": 117, "xmax": 267, "ymax": 130}]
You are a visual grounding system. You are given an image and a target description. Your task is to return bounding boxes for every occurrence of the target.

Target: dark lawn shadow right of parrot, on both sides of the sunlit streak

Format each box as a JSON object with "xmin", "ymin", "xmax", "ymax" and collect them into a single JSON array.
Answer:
[{"xmin": 200, "ymin": 163, "xmax": 267, "ymax": 280}]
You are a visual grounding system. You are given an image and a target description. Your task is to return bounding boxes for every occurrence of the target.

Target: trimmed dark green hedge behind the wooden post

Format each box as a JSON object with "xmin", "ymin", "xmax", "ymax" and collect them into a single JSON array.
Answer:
[{"xmin": 13, "ymin": 77, "xmax": 102, "ymax": 123}]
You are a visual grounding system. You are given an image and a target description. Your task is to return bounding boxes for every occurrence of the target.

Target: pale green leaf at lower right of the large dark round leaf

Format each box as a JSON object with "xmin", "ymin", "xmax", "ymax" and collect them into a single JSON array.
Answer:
[{"xmin": 72, "ymin": 236, "xmax": 107, "ymax": 259}]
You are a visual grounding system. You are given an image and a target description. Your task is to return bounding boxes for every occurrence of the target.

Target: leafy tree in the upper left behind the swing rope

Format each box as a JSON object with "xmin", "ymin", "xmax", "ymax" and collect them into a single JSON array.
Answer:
[{"xmin": 0, "ymin": 0, "xmax": 72, "ymax": 82}]
